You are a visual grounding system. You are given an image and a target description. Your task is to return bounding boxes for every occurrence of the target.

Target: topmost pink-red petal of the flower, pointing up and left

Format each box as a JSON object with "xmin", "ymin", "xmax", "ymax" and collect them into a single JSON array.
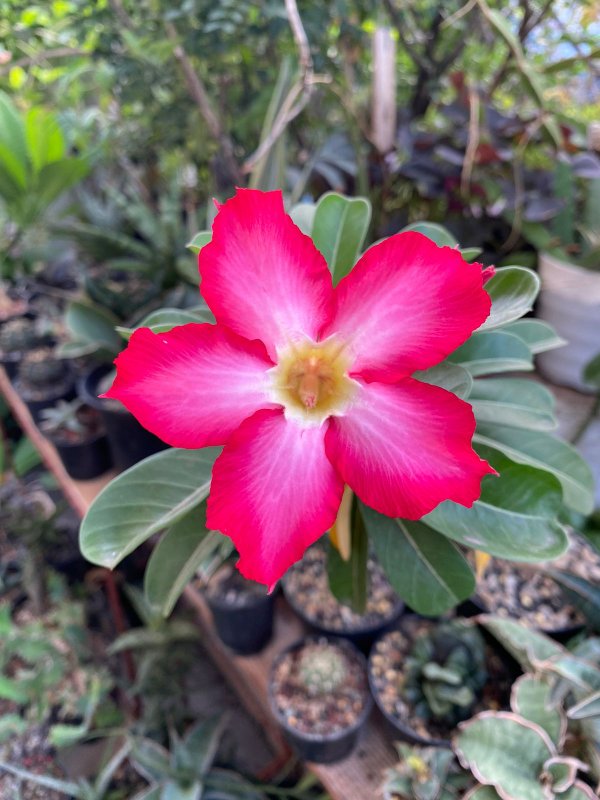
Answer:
[{"xmin": 198, "ymin": 189, "xmax": 333, "ymax": 358}]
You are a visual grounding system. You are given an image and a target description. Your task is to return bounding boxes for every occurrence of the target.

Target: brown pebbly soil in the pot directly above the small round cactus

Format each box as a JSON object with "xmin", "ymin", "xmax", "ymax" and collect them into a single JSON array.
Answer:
[{"xmin": 283, "ymin": 545, "xmax": 401, "ymax": 632}]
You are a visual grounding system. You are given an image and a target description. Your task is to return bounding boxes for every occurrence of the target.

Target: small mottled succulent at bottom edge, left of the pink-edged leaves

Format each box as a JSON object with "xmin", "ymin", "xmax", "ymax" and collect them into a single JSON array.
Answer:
[{"xmin": 383, "ymin": 743, "xmax": 471, "ymax": 800}]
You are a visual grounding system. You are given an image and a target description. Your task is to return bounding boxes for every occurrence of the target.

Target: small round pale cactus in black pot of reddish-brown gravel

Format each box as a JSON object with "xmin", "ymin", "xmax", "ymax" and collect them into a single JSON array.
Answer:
[{"xmin": 269, "ymin": 637, "xmax": 373, "ymax": 764}]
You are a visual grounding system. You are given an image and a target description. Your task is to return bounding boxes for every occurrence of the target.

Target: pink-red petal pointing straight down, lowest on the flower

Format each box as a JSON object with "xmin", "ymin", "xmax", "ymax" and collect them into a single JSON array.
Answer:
[{"xmin": 207, "ymin": 411, "xmax": 344, "ymax": 588}]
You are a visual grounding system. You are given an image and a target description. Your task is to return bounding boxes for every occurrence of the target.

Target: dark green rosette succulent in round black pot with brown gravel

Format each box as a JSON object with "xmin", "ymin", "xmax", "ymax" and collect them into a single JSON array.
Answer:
[{"xmin": 369, "ymin": 617, "xmax": 499, "ymax": 747}]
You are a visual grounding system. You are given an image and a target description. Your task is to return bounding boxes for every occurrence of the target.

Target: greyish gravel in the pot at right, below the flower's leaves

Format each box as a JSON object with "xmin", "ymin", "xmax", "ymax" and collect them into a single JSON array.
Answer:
[{"xmin": 475, "ymin": 534, "xmax": 600, "ymax": 631}]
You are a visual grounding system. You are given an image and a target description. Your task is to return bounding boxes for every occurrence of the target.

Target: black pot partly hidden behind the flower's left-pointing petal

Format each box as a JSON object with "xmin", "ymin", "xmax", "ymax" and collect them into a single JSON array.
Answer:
[{"xmin": 79, "ymin": 364, "xmax": 168, "ymax": 470}]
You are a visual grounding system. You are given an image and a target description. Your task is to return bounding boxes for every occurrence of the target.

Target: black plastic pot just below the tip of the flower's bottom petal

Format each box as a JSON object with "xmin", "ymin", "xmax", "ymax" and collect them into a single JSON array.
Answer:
[{"xmin": 206, "ymin": 594, "xmax": 275, "ymax": 656}]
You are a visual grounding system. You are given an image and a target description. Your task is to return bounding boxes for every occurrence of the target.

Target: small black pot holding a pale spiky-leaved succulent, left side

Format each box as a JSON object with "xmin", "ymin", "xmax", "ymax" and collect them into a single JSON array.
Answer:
[{"xmin": 40, "ymin": 399, "xmax": 112, "ymax": 481}]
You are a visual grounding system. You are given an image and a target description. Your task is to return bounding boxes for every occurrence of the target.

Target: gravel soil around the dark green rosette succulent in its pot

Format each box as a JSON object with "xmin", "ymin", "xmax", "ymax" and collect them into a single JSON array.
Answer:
[{"xmin": 369, "ymin": 617, "xmax": 512, "ymax": 740}]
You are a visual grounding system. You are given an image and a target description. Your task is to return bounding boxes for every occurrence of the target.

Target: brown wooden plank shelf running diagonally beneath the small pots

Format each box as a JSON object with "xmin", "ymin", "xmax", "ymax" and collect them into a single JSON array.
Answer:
[{"xmin": 0, "ymin": 367, "xmax": 396, "ymax": 800}]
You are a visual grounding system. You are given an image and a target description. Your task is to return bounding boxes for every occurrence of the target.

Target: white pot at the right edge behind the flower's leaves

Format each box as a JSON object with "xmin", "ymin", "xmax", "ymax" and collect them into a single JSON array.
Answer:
[{"xmin": 537, "ymin": 247, "xmax": 600, "ymax": 392}]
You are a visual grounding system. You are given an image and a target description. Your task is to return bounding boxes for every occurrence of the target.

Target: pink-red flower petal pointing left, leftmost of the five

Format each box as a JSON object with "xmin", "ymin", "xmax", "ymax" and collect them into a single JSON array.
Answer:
[{"xmin": 104, "ymin": 323, "xmax": 277, "ymax": 448}]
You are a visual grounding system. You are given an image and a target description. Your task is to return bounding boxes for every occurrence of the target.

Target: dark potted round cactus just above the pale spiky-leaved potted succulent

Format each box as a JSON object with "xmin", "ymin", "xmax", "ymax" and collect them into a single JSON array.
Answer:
[{"xmin": 15, "ymin": 347, "xmax": 75, "ymax": 422}]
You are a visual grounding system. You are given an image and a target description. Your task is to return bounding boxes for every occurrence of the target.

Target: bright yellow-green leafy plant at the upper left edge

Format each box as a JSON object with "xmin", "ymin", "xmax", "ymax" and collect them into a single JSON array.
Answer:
[{"xmin": 0, "ymin": 92, "xmax": 89, "ymax": 277}]
